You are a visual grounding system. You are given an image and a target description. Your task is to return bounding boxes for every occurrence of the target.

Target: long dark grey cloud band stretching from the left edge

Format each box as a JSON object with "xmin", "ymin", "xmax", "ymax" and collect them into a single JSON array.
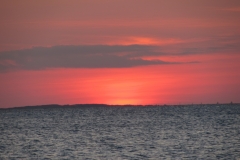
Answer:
[{"xmin": 0, "ymin": 45, "xmax": 170, "ymax": 72}]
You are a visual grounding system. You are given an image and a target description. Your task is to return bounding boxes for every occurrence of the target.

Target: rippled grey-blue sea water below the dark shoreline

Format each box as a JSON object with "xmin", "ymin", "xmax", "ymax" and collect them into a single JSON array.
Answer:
[{"xmin": 0, "ymin": 105, "xmax": 240, "ymax": 160}]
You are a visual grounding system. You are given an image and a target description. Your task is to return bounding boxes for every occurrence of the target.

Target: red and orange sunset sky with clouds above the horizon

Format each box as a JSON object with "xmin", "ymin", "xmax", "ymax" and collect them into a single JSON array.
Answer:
[{"xmin": 0, "ymin": 0, "xmax": 240, "ymax": 108}]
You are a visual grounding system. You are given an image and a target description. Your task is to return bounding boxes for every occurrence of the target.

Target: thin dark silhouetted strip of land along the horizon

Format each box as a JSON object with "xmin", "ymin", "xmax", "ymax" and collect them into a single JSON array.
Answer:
[{"xmin": 0, "ymin": 102, "xmax": 240, "ymax": 109}]
